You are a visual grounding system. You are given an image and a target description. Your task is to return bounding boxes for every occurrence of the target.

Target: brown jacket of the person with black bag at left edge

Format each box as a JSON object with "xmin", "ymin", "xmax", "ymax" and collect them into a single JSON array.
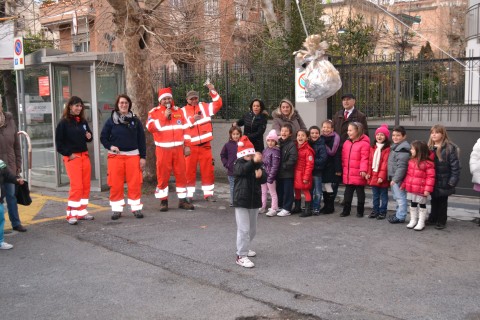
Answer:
[{"xmin": 0, "ymin": 112, "xmax": 22, "ymax": 174}]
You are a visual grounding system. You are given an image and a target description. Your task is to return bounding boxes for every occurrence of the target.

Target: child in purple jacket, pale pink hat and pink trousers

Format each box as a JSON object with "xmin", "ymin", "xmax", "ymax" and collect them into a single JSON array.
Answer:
[{"xmin": 259, "ymin": 130, "xmax": 280, "ymax": 217}]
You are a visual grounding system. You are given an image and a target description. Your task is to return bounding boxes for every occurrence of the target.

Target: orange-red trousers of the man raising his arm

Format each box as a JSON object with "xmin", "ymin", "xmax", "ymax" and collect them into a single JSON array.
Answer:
[{"xmin": 185, "ymin": 141, "xmax": 215, "ymax": 198}]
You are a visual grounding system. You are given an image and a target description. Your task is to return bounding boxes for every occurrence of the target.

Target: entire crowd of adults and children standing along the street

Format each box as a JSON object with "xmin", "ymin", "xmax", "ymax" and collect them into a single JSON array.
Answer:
[{"xmin": 0, "ymin": 90, "xmax": 472, "ymax": 267}]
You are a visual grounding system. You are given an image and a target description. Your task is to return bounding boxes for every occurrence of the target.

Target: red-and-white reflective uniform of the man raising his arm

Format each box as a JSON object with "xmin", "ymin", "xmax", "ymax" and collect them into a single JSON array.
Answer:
[{"xmin": 182, "ymin": 90, "xmax": 222, "ymax": 198}]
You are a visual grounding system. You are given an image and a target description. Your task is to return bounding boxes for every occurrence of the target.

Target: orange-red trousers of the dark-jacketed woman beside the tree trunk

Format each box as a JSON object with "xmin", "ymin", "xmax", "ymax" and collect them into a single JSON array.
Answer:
[{"xmin": 107, "ymin": 153, "xmax": 143, "ymax": 212}]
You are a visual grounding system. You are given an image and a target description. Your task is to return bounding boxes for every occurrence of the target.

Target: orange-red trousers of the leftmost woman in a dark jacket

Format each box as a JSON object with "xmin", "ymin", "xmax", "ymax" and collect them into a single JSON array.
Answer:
[{"xmin": 63, "ymin": 151, "xmax": 92, "ymax": 219}]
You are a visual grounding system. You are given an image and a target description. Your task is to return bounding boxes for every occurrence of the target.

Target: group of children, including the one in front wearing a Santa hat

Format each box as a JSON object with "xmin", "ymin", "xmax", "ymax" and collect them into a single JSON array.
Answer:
[{"xmin": 221, "ymin": 120, "xmax": 460, "ymax": 267}]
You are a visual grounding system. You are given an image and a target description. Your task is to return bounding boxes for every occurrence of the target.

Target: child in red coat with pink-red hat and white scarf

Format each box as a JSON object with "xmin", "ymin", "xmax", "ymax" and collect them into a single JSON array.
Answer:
[{"xmin": 367, "ymin": 124, "xmax": 390, "ymax": 220}]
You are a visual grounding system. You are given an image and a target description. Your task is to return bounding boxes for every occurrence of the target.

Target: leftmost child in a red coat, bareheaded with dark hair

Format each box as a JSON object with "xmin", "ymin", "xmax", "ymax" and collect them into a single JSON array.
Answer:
[{"xmin": 292, "ymin": 129, "xmax": 315, "ymax": 217}]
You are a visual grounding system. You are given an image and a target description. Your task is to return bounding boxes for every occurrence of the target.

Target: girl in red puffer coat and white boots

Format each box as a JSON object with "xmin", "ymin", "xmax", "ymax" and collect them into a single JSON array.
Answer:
[{"xmin": 402, "ymin": 141, "xmax": 435, "ymax": 231}]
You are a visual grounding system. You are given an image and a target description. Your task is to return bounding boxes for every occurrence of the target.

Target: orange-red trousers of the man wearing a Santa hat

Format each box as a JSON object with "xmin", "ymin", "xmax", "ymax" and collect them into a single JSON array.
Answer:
[{"xmin": 155, "ymin": 146, "xmax": 187, "ymax": 200}]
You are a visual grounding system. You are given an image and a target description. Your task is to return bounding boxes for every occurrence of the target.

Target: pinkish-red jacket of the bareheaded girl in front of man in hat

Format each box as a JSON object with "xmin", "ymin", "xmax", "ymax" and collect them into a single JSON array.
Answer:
[{"xmin": 342, "ymin": 134, "xmax": 370, "ymax": 186}]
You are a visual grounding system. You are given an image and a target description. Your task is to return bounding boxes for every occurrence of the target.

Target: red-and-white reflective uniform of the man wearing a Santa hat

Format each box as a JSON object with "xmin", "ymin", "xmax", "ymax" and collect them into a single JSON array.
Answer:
[{"xmin": 147, "ymin": 99, "xmax": 187, "ymax": 200}]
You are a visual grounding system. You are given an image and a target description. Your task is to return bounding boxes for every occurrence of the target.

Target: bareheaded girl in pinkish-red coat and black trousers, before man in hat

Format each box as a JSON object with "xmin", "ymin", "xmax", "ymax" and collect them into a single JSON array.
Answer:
[{"xmin": 340, "ymin": 122, "xmax": 370, "ymax": 218}]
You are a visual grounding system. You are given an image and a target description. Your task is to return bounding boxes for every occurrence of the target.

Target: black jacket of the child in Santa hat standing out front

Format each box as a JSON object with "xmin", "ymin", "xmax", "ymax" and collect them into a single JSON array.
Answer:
[{"xmin": 233, "ymin": 158, "xmax": 267, "ymax": 209}]
